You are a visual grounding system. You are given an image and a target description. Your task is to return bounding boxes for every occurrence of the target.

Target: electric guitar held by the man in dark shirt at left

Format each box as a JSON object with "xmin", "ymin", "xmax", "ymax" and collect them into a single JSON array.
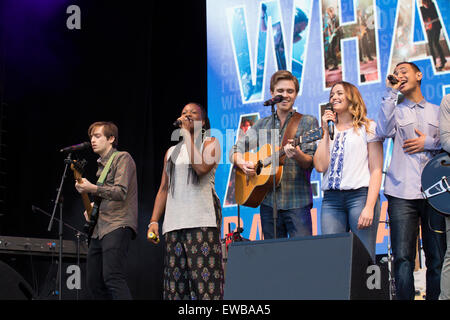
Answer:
[{"xmin": 70, "ymin": 159, "xmax": 101, "ymax": 240}]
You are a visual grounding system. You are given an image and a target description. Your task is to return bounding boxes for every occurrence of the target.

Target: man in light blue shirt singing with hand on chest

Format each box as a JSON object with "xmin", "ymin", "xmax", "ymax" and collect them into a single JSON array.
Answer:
[{"xmin": 376, "ymin": 62, "xmax": 446, "ymax": 300}]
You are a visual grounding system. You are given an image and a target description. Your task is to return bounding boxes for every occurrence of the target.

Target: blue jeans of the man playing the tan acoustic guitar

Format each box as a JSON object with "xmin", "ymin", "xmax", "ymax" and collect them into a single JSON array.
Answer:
[{"xmin": 260, "ymin": 204, "xmax": 312, "ymax": 239}]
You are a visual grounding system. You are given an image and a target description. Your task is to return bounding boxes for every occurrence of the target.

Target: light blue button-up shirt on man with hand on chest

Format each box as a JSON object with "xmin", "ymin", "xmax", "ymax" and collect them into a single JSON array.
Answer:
[{"xmin": 376, "ymin": 88, "xmax": 441, "ymax": 199}]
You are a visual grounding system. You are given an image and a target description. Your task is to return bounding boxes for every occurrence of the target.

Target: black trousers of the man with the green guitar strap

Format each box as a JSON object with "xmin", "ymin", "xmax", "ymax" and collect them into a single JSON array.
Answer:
[{"xmin": 87, "ymin": 227, "xmax": 133, "ymax": 300}]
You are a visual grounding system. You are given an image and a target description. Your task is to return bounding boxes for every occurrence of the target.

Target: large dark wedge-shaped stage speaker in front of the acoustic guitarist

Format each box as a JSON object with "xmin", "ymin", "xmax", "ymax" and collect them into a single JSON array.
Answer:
[{"xmin": 224, "ymin": 233, "xmax": 388, "ymax": 300}]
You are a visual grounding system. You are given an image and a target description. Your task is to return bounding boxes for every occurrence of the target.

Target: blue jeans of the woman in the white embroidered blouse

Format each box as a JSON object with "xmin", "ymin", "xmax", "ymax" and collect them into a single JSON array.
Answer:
[{"xmin": 320, "ymin": 188, "xmax": 380, "ymax": 261}]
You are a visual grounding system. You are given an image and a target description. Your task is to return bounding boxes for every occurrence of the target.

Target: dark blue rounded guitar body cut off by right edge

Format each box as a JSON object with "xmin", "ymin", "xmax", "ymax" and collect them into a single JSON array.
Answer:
[{"xmin": 421, "ymin": 152, "xmax": 450, "ymax": 217}]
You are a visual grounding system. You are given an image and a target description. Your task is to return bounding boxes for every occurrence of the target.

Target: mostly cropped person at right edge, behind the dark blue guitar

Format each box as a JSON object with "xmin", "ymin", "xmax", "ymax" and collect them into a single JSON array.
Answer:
[{"xmin": 439, "ymin": 94, "xmax": 450, "ymax": 300}]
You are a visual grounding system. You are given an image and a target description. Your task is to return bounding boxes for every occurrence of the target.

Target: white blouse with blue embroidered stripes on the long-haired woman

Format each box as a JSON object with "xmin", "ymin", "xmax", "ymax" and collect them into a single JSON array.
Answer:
[{"xmin": 322, "ymin": 121, "xmax": 383, "ymax": 190}]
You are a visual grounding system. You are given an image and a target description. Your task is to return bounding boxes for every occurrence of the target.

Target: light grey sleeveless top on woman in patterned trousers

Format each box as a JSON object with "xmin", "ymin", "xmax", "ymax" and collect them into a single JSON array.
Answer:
[{"xmin": 162, "ymin": 144, "xmax": 217, "ymax": 234}]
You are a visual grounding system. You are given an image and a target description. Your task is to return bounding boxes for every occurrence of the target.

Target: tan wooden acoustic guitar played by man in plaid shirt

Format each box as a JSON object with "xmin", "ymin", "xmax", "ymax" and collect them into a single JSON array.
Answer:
[{"xmin": 235, "ymin": 128, "xmax": 323, "ymax": 208}]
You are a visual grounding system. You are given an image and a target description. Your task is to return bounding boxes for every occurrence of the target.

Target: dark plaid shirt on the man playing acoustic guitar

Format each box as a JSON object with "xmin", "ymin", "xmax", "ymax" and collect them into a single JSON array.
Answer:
[{"xmin": 230, "ymin": 111, "xmax": 319, "ymax": 210}]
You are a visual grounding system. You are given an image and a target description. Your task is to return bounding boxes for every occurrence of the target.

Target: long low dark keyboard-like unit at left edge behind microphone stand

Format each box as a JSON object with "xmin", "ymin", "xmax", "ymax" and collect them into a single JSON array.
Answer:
[{"xmin": 0, "ymin": 236, "xmax": 88, "ymax": 258}]
